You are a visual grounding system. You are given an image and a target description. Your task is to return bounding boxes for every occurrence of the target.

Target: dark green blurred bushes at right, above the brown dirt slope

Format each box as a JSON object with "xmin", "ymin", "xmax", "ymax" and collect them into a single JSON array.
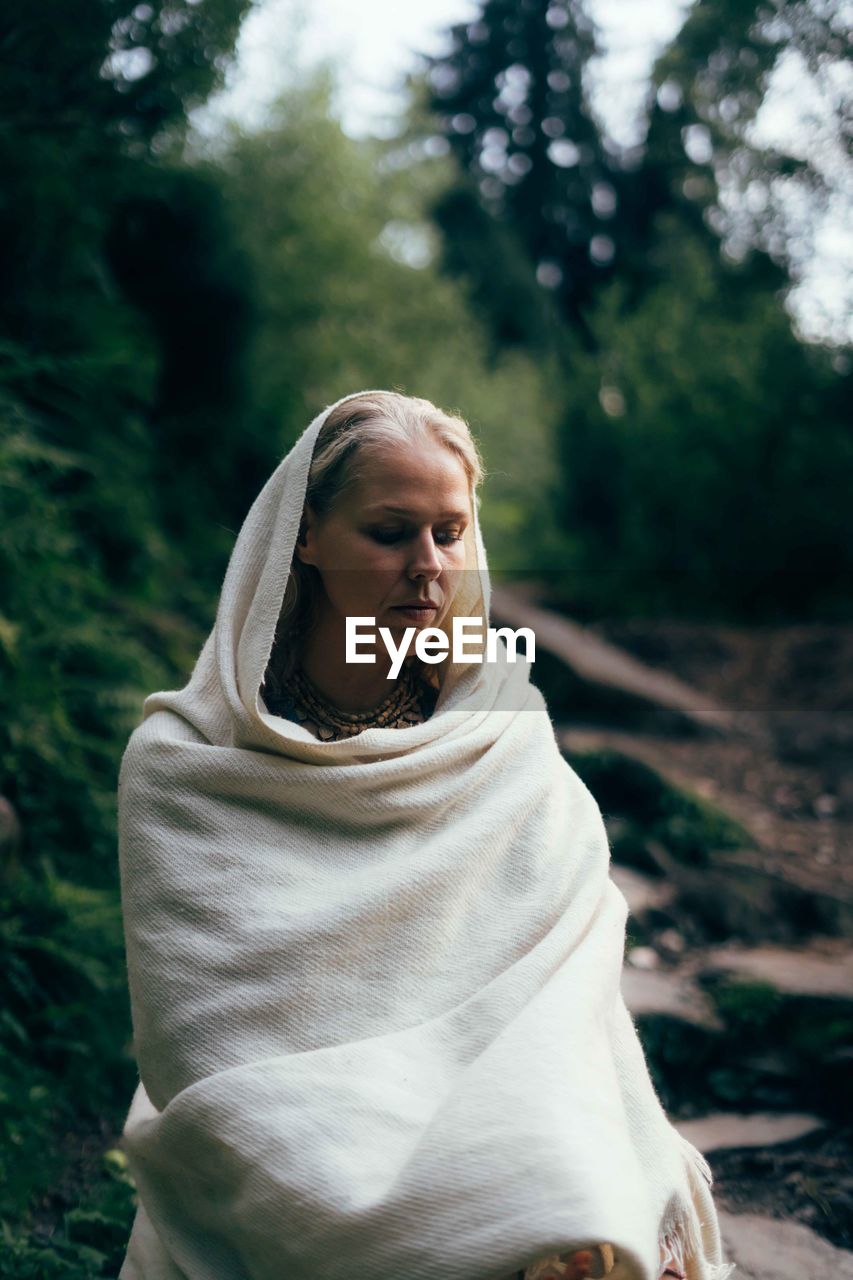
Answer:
[{"xmin": 548, "ymin": 227, "xmax": 853, "ymax": 617}]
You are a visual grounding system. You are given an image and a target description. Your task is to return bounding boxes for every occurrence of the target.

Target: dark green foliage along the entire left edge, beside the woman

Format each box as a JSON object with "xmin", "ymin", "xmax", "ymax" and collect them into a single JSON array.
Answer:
[{"xmin": 0, "ymin": 0, "xmax": 246, "ymax": 1254}]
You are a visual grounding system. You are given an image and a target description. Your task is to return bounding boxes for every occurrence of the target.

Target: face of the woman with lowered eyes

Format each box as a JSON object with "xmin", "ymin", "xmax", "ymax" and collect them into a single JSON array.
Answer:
[{"xmin": 296, "ymin": 442, "xmax": 471, "ymax": 634}]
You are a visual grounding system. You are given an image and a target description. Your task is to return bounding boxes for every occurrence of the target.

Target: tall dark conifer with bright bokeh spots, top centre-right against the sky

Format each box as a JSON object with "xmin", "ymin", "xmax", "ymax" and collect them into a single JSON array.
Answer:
[{"xmin": 425, "ymin": 0, "xmax": 619, "ymax": 344}]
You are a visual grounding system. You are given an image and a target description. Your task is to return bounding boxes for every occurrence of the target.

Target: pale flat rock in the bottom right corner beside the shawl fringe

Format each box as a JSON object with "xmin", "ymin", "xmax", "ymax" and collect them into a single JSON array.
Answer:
[{"xmin": 719, "ymin": 1210, "xmax": 853, "ymax": 1280}]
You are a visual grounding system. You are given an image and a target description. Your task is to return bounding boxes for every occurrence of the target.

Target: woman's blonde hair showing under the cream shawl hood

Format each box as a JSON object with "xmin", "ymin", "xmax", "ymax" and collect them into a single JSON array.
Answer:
[{"xmin": 265, "ymin": 392, "xmax": 483, "ymax": 685}]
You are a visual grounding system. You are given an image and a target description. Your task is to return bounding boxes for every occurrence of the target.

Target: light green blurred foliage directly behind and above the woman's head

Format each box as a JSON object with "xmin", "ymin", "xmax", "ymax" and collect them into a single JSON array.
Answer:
[{"xmin": 219, "ymin": 77, "xmax": 561, "ymax": 570}]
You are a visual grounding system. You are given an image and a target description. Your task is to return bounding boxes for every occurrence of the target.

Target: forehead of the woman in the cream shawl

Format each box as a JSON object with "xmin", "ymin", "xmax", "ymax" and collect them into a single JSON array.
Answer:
[{"xmin": 348, "ymin": 440, "xmax": 470, "ymax": 513}]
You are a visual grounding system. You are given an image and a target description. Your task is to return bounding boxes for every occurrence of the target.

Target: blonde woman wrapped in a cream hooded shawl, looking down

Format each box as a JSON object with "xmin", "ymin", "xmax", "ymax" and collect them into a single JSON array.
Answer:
[{"xmin": 119, "ymin": 392, "xmax": 731, "ymax": 1280}]
